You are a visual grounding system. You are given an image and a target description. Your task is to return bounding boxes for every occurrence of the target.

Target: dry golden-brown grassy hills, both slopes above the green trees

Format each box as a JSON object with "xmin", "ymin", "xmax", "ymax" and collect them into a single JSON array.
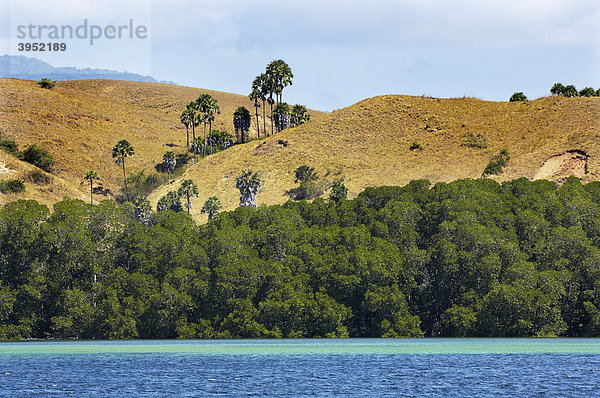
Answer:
[{"xmin": 0, "ymin": 79, "xmax": 600, "ymax": 220}]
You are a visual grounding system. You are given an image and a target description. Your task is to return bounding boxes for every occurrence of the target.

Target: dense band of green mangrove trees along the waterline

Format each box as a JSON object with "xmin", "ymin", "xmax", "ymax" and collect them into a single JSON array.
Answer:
[{"xmin": 0, "ymin": 178, "xmax": 600, "ymax": 339}]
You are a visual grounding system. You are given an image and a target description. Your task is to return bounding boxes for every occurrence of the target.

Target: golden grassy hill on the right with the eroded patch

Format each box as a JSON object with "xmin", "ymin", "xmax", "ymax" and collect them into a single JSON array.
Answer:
[{"xmin": 146, "ymin": 95, "xmax": 600, "ymax": 219}]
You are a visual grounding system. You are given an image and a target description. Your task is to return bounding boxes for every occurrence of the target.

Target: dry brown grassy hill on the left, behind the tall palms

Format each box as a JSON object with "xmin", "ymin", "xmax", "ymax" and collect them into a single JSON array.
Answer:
[{"xmin": 0, "ymin": 79, "xmax": 318, "ymax": 204}]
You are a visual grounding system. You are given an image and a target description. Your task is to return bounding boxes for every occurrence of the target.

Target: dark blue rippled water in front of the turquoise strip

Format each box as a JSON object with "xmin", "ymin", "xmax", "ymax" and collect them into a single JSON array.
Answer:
[{"xmin": 0, "ymin": 340, "xmax": 600, "ymax": 397}]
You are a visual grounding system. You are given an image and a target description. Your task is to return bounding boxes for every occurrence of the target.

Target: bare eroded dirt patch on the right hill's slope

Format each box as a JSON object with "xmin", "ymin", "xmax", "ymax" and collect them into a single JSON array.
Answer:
[{"xmin": 533, "ymin": 149, "xmax": 589, "ymax": 181}]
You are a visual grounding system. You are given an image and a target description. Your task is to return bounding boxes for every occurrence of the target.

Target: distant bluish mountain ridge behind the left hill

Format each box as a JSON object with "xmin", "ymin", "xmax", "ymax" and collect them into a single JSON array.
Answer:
[{"xmin": 0, "ymin": 55, "xmax": 176, "ymax": 84}]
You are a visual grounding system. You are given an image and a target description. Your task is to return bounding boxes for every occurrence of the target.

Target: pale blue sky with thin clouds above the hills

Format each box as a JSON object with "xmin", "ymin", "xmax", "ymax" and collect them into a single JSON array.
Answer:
[{"xmin": 0, "ymin": 0, "xmax": 600, "ymax": 111}]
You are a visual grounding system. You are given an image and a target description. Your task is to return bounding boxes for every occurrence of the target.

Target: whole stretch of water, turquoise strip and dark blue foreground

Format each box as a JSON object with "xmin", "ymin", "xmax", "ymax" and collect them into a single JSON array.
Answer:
[{"xmin": 0, "ymin": 339, "xmax": 600, "ymax": 397}]
